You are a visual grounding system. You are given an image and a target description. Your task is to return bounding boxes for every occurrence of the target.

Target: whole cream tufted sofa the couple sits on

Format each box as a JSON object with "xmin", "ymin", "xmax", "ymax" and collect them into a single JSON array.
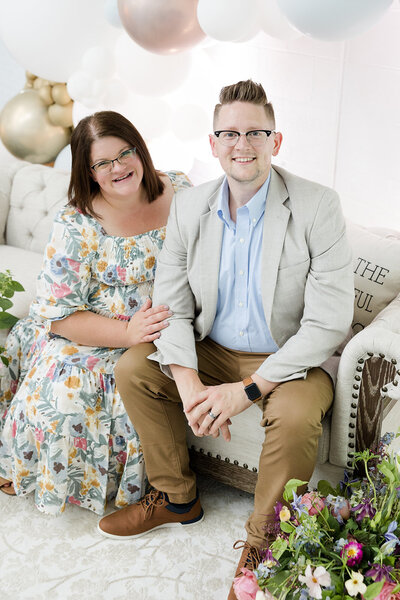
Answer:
[{"xmin": 0, "ymin": 161, "xmax": 400, "ymax": 491}]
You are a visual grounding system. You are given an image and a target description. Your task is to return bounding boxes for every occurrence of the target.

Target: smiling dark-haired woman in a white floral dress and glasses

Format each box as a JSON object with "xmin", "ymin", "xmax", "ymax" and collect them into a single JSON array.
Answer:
[{"xmin": 0, "ymin": 111, "xmax": 191, "ymax": 514}]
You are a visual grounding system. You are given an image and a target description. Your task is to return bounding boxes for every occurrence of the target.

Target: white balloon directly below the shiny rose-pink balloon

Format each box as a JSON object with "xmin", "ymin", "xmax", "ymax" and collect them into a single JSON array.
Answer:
[{"xmin": 115, "ymin": 32, "xmax": 190, "ymax": 96}]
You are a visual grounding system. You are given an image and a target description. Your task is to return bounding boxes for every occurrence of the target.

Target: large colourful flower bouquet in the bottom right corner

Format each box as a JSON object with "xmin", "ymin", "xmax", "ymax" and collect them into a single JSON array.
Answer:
[{"xmin": 234, "ymin": 434, "xmax": 400, "ymax": 600}]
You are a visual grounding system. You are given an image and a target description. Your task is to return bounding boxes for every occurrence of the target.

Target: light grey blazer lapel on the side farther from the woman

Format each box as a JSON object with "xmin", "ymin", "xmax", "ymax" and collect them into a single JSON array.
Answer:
[{"xmin": 261, "ymin": 168, "xmax": 290, "ymax": 326}]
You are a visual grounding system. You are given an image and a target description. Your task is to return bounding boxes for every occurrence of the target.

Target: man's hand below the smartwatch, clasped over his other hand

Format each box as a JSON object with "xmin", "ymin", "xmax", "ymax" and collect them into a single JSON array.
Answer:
[{"xmin": 185, "ymin": 381, "xmax": 252, "ymax": 441}]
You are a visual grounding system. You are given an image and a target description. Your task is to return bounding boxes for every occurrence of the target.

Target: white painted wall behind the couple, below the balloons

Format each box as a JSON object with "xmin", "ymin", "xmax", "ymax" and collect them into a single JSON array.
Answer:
[{"xmin": 0, "ymin": 0, "xmax": 400, "ymax": 229}]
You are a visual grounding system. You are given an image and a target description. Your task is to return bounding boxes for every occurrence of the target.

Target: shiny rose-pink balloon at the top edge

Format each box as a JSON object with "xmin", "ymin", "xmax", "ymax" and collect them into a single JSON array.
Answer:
[{"xmin": 118, "ymin": 0, "xmax": 205, "ymax": 54}]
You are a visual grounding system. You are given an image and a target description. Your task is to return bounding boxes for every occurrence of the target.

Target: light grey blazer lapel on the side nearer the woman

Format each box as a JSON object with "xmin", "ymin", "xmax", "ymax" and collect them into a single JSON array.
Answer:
[{"xmin": 200, "ymin": 180, "xmax": 223, "ymax": 332}]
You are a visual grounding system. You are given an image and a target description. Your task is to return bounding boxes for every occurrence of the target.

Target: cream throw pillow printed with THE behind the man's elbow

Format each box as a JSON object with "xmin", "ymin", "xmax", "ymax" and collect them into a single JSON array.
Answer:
[{"xmin": 347, "ymin": 223, "xmax": 400, "ymax": 333}]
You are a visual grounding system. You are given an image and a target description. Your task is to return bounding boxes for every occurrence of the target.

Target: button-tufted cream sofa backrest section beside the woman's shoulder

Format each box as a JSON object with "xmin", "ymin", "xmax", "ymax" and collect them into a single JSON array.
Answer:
[{"xmin": 6, "ymin": 164, "xmax": 70, "ymax": 254}]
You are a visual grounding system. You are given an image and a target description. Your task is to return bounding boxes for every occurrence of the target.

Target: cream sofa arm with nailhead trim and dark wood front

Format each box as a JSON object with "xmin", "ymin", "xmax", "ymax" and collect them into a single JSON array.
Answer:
[{"xmin": 329, "ymin": 295, "xmax": 400, "ymax": 468}]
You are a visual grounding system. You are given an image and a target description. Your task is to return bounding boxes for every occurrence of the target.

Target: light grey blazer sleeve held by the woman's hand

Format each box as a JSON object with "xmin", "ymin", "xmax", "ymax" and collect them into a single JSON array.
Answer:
[{"xmin": 148, "ymin": 194, "xmax": 197, "ymax": 378}]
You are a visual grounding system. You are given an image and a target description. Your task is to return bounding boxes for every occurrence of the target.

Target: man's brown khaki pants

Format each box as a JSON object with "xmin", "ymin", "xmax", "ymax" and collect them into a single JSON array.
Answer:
[{"xmin": 115, "ymin": 338, "xmax": 333, "ymax": 546}]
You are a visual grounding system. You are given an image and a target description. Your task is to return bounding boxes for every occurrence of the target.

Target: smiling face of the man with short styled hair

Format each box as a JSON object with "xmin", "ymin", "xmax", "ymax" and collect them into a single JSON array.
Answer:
[{"xmin": 210, "ymin": 102, "xmax": 282, "ymax": 188}]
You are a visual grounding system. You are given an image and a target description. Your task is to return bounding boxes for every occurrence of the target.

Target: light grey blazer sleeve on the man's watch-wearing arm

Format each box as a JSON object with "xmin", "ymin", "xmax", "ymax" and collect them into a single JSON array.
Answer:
[{"xmin": 257, "ymin": 189, "xmax": 354, "ymax": 382}]
